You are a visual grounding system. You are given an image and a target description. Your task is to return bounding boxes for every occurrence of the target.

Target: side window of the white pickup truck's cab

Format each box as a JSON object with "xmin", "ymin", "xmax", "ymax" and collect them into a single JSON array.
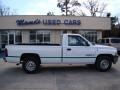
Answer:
[{"xmin": 68, "ymin": 35, "xmax": 89, "ymax": 46}]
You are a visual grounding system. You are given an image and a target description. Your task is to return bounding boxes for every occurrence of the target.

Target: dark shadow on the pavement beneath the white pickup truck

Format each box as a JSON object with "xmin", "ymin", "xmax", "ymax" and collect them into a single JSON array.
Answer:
[{"xmin": 0, "ymin": 65, "xmax": 118, "ymax": 76}]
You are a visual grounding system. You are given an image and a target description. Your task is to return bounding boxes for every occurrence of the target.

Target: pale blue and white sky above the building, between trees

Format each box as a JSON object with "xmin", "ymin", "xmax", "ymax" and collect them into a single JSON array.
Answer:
[{"xmin": 2, "ymin": 0, "xmax": 120, "ymax": 17}]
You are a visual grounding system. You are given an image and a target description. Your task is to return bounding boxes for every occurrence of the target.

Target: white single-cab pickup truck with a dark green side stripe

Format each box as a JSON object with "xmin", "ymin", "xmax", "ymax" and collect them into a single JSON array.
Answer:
[{"xmin": 4, "ymin": 34, "xmax": 118, "ymax": 73}]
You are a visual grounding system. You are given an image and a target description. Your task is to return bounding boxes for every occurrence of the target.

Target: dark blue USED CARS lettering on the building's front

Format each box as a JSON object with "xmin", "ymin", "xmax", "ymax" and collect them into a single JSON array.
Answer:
[{"xmin": 16, "ymin": 19, "xmax": 81, "ymax": 26}]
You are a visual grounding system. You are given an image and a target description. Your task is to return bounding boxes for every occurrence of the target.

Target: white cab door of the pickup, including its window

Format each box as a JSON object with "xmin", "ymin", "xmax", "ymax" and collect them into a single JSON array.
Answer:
[{"xmin": 63, "ymin": 35, "xmax": 96, "ymax": 64}]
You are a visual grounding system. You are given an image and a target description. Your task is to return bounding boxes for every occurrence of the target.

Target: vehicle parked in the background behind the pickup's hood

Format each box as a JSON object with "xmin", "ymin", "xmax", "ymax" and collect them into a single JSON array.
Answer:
[{"xmin": 98, "ymin": 37, "xmax": 120, "ymax": 53}]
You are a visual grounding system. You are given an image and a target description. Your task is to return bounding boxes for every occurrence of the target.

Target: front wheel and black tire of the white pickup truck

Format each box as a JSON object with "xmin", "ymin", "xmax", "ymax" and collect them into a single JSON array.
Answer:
[{"xmin": 95, "ymin": 56, "xmax": 112, "ymax": 72}]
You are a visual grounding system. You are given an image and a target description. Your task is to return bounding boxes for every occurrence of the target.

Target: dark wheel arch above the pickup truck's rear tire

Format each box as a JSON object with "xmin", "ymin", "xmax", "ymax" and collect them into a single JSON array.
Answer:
[{"xmin": 20, "ymin": 53, "xmax": 41, "ymax": 64}]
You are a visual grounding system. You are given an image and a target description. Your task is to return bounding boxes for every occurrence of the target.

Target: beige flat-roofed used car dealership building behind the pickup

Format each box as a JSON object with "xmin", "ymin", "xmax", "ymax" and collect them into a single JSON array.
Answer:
[{"xmin": 0, "ymin": 15, "xmax": 111, "ymax": 48}]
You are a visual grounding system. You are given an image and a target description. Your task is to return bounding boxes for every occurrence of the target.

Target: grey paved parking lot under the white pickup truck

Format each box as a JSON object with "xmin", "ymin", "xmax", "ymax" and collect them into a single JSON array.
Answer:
[{"xmin": 0, "ymin": 58, "xmax": 120, "ymax": 90}]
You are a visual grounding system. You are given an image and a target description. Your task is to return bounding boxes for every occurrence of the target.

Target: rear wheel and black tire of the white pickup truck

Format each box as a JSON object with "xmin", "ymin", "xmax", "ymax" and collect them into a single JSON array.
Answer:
[{"xmin": 22, "ymin": 57, "xmax": 40, "ymax": 74}]
